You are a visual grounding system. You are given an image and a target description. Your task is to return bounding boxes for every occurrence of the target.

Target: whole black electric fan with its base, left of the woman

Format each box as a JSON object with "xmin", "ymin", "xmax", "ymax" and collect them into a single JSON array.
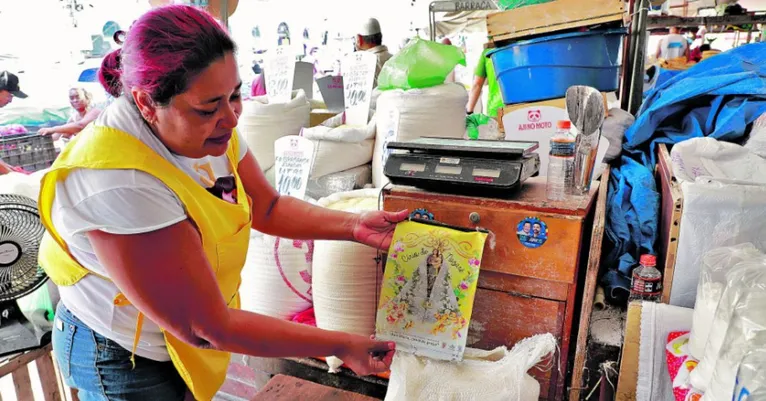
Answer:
[{"xmin": 0, "ymin": 195, "xmax": 51, "ymax": 355}]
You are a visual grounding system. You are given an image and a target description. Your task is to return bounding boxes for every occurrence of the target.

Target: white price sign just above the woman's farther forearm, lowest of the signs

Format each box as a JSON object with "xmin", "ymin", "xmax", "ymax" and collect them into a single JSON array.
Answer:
[{"xmin": 274, "ymin": 135, "xmax": 314, "ymax": 199}]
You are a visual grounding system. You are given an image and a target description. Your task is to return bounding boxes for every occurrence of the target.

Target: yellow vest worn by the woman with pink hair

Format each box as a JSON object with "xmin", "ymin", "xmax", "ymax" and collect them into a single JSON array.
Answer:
[{"xmin": 39, "ymin": 125, "xmax": 251, "ymax": 400}]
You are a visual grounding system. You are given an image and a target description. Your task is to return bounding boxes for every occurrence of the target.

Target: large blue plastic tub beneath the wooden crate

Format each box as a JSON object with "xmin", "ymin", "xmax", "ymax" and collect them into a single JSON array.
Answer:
[{"xmin": 487, "ymin": 29, "xmax": 627, "ymax": 104}]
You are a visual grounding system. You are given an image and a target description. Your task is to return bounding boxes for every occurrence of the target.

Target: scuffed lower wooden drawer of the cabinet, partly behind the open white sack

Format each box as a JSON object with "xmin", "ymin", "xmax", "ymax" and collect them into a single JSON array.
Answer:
[{"xmin": 466, "ymin": 288, "xmax": 566, "ymax": 399}]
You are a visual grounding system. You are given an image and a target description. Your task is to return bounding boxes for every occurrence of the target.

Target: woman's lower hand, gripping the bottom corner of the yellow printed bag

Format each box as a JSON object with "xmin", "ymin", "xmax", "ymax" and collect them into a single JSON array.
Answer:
[{"xmin": 336, "ymin": 335, "xmax": 396, "ymax": 376}]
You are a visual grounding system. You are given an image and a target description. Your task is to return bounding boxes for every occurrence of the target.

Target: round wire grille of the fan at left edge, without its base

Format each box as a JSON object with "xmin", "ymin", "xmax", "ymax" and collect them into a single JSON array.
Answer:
[{"xmin": 0, "ymin": 195, "xmax": 47, "ymax": 302}]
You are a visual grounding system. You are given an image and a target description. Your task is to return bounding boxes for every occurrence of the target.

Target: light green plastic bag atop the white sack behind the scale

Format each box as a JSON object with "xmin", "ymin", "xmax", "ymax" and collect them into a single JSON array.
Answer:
[{"xmin": 378, "ymin": 38, "xmax": 466, "ymax": 91}]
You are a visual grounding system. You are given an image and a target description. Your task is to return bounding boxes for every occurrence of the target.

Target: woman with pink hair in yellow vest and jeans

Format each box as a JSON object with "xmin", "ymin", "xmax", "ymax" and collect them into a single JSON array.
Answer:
[{"xmin": 39, "ymin": 5, "xmax": 407, "ymax": 401}]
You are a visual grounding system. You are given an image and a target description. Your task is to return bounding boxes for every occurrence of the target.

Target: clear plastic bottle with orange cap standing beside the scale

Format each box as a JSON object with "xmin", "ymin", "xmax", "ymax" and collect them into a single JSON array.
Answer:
[{"xmin": 545, "ymin": 121, "xmax": 575, "ymax": 200}]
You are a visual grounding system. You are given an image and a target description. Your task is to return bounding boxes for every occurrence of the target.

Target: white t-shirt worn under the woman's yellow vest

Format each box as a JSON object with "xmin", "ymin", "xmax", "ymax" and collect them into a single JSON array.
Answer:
[{"xmin": 52, "ymin": 98, "xmax": 247, "ymax": 361}]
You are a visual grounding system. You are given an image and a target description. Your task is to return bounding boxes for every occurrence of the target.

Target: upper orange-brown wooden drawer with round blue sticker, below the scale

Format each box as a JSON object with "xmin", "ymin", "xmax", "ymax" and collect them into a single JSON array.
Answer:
[{"xmin": 383, "ymin": 195, "xmax": 582, "ymax": 284}]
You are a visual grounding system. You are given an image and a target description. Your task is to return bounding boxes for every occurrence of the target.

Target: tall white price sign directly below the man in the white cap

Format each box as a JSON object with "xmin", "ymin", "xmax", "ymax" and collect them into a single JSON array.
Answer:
[{"xmin": 341, "ymin": 52, "xmax": 378, "ymax": 125}]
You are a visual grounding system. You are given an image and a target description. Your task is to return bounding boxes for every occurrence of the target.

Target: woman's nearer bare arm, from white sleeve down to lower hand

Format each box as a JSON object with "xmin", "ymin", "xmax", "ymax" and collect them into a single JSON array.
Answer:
[{"xmin": 88, "ymin": 220, "xmax": 394, "ymax": 374}]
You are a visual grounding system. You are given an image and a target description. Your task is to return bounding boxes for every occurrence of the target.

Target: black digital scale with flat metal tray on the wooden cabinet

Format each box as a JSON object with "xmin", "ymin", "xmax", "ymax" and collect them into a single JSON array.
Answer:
[{"xmin": 383, "ymin": 137, "xmax": 540, "ymax": 198}]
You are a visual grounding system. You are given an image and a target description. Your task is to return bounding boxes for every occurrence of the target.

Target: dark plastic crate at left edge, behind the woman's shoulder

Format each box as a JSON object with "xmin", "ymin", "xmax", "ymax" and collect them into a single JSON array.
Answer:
[{"xmin": 0, "ymin": 133, "xmax": 56, "ymax": 172}]
